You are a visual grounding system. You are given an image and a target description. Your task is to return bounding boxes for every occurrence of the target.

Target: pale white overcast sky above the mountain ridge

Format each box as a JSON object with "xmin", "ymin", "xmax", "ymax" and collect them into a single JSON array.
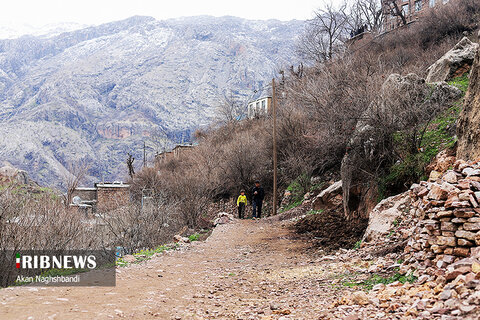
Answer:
[{"xmin": 0, "ymin": 0, "xmax": 322, "ymax": 26}]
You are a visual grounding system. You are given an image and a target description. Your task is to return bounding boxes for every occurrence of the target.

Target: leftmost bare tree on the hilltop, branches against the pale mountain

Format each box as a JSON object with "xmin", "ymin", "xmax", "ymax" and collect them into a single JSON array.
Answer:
[{"xmin": 299, "ymin": 4, "xmax": 347, "ymax": 63}]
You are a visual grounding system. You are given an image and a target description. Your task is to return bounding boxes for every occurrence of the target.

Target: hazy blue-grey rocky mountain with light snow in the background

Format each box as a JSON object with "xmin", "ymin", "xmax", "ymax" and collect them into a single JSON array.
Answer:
[{"xmin": 0, "ymin": 16, "xmax": 303, "ymax": 186}]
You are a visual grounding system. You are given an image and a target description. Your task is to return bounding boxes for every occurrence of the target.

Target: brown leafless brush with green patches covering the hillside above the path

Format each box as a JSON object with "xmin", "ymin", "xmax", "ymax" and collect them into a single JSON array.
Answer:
[{"xmin": 133, "ymin": 0, "xmax": 480, "ymax": 222}]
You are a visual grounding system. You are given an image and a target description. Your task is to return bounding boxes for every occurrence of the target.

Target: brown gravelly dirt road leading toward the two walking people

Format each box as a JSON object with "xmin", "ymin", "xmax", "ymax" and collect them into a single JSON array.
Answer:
[{"xmin": 0, "ymin": 220, "xmax": 344, "ymax": 319}]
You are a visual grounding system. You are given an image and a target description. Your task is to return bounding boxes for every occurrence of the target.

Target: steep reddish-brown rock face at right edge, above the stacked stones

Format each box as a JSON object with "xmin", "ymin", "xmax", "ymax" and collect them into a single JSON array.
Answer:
[{"xmin": 457, "ymin": 44, "xmax": 480, "ymax": 160}]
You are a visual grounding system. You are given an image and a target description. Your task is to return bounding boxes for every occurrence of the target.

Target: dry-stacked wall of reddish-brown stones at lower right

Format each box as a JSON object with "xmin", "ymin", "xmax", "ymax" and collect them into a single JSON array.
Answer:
[{"xmin": 405, "ymin": 160, "xmax": 480, "ymax": 268}]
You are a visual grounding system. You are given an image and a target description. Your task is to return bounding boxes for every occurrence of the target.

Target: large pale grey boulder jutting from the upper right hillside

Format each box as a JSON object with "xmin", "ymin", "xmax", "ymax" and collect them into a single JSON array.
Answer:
[{"xmin": 425, "ymin": 38, "xmax": 478, "ymax": 83}]
